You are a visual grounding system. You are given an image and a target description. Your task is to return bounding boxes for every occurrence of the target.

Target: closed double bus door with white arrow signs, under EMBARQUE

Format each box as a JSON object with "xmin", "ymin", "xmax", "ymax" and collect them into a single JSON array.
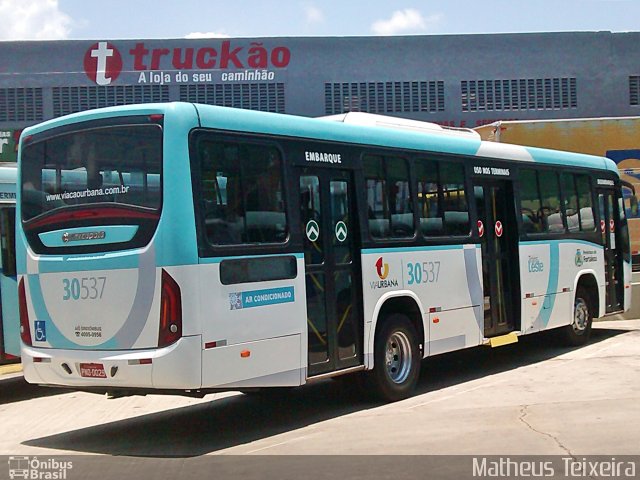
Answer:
[{"xmin": 298, "ymin": 168, "xmax": 363, "ymax": 376}]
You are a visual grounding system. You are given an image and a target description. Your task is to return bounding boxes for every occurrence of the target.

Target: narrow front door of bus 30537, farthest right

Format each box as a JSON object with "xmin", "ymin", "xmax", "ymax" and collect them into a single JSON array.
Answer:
[{"xmin": 597, "ymin": 188, "xmax": 624, "ymax": 313}]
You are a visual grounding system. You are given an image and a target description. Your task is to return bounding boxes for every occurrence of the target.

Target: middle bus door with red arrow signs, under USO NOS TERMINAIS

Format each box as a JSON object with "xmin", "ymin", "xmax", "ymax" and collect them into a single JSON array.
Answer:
[{"xmin": 474, "ymin": 179, "xmax": 520, "ymax": 338}]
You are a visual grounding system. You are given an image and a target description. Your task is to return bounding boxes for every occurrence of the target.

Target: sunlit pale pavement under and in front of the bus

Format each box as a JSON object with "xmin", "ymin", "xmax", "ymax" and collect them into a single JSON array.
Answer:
[{"xmin": 0, "ymin": 320, "xmax": 640, "ymax": 458}]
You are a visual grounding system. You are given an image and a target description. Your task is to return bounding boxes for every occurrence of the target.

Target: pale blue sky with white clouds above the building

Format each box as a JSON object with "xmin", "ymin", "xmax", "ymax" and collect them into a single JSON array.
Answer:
[{"xmin": 0, "ymin": 0, "xmax": 640, "ymax": 40}]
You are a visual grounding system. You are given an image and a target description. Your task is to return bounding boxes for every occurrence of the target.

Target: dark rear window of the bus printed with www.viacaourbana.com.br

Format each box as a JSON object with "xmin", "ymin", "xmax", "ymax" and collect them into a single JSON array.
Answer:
[{"xmin": 21, "ymin": 125, "xmax": 162, "ymax": 222}]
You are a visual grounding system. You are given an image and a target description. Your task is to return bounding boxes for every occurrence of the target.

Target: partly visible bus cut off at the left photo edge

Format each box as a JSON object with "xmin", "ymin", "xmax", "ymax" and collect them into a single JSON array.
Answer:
[{"xmin": 0, "ymin": 162, "xmax": 20, "ymax": 363}]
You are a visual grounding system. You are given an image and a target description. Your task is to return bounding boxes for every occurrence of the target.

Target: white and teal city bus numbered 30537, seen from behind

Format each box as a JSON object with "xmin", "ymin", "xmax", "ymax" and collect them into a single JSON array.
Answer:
[{"xmin": 17, "ymin": 103, "xmax": 631, "ymax": 400}]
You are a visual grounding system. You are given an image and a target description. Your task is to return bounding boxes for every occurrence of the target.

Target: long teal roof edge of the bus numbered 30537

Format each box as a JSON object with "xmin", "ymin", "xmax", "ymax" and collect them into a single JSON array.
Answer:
[{"xmin": 21, "ymin": 102, "xmax": 618, "ymax": 174}]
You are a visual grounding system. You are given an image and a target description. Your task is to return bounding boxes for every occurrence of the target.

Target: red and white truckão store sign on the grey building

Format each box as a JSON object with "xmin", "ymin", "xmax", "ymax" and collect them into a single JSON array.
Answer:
[{"xmin": 84, "ymin": 40, "xmax": 291, "ymax": 85}]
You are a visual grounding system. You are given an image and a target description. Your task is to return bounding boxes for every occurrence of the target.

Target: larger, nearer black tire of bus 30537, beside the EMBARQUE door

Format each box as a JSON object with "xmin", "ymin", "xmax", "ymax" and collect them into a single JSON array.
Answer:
[{"xmin": 367, "ymin": 313, "xmax": 422, "ymax": 402}]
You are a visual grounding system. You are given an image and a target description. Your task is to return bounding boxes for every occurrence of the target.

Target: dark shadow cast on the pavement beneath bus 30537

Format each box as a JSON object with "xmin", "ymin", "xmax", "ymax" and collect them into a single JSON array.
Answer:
[{"xmin": 24, "ymin": 328, "xmax": 625, "ymax": 457}]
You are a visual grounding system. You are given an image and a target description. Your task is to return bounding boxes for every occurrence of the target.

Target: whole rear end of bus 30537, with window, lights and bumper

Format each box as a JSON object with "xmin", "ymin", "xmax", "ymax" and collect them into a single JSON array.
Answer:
[{"xmin": 18, "ymin": 107, "xmax": 201, "ymax": 389}]
